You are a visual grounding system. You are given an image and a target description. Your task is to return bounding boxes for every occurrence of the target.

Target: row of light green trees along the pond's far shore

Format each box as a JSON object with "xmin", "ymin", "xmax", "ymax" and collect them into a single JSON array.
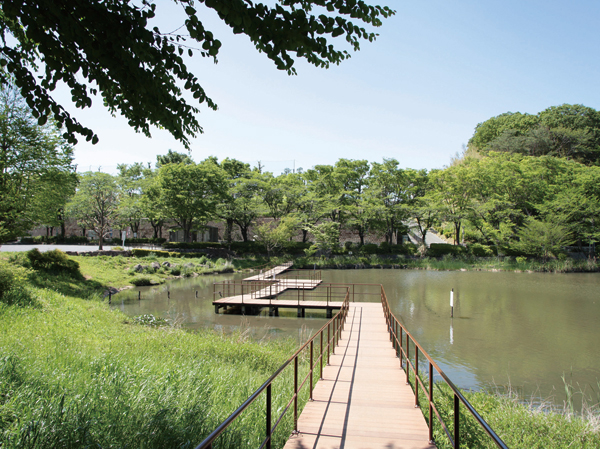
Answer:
[{"xmin": 9, "ymin": 147, "xmax": 600, "ymax": 258}]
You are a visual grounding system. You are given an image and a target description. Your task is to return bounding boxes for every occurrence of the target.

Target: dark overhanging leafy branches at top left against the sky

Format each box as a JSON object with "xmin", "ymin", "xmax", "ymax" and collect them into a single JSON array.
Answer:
[{"xmin": 0, "ymin": 0, "xmax": 394, "ymax": 147}]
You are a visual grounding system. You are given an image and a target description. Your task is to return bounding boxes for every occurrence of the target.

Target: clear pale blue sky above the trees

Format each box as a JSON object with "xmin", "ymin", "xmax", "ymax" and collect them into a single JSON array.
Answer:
[{"xmin": 59, "ymin": 0, "xmax": 600, "ymax": 173}]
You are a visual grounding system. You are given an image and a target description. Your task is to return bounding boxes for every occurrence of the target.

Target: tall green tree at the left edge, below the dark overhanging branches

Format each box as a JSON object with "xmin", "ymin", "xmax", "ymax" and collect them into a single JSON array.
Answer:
[{"xmin": 0, "ymin": 80, "xmax": 77, "ymax": 244}]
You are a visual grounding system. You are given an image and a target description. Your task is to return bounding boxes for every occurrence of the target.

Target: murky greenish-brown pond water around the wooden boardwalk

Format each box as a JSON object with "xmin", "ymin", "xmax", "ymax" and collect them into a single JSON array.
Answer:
[{"xmin": 113, "ymin": 269, "xmax": 600, "ymax": 406}]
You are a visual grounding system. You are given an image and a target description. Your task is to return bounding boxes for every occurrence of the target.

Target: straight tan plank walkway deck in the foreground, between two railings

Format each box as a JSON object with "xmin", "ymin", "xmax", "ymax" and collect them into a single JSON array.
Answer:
[{"xmin": 285, "ymin": 303, "xmax": 435, "ymax": 449}]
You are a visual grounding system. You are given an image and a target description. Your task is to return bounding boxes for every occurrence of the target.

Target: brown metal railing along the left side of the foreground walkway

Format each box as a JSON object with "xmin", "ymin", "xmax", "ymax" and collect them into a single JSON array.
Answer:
[{"xmin": 196, "ymin": 288, "xmax": 350, "ymax": 449}]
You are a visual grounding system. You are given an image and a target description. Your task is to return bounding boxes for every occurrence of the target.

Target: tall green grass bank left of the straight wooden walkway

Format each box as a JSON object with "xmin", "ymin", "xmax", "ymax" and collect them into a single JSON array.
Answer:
[{"xmin": 0, "ymin": 254, "xmax": 306, "ymax": 449}]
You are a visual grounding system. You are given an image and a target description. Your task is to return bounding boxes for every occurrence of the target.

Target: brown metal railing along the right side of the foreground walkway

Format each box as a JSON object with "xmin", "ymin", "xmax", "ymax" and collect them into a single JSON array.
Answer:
[{"xmin": 381, "ymin": 286, "xmax": 507, "ymax": 449}]
